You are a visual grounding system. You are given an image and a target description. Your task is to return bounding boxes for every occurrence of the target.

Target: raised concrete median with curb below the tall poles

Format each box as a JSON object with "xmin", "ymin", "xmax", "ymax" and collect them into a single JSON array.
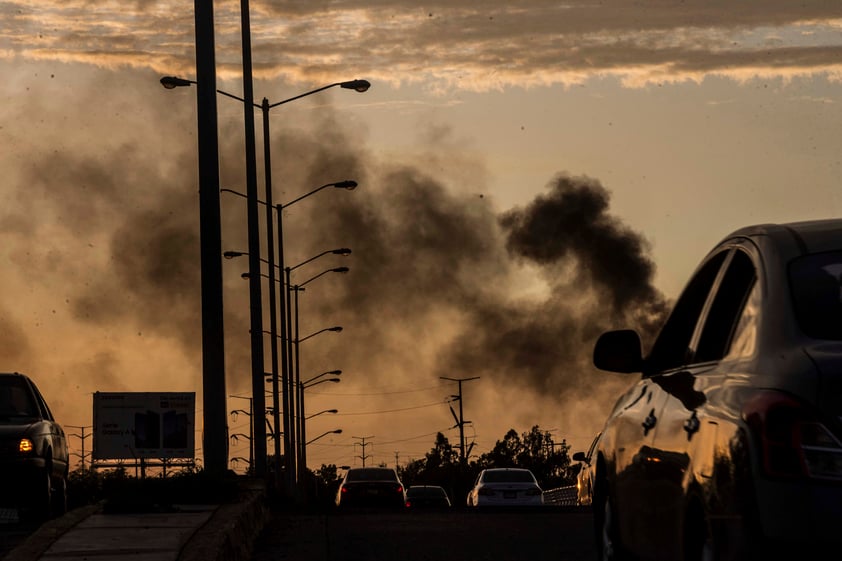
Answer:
[{"xmin": 3, "ymin": 485, "xmax": 269, "ymax": 561}]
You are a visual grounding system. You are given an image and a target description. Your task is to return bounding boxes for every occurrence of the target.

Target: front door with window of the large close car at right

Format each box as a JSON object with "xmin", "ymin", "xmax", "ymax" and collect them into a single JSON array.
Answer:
[{"xmin": 615, "ymin": 251, "xmax": 728, "ymax": 558}]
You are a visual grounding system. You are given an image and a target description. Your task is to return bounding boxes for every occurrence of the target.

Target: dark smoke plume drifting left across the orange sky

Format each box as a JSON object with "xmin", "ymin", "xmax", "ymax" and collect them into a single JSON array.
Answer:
[{"xmin": 0, "ymin": 61, "xmax": 665, "ymax": 445}]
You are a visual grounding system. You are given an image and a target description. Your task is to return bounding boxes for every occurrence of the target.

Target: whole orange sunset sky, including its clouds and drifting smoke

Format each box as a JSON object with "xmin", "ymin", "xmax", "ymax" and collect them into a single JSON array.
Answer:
[{"xmin": 0, "ymin": 0, "xmax": 842, "ymax": 469}]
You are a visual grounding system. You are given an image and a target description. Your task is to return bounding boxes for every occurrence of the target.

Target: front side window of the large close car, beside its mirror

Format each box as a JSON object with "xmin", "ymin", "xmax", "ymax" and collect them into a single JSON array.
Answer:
[{"xmin": 646, "ymin": 250, "xmax": 728, "ymax": 375}]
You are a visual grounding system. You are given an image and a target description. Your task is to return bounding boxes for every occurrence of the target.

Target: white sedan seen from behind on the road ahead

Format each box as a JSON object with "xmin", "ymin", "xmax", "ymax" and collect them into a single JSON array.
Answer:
[{"xmin": 468, "ymin": 468, "xmax": 544, "ymax": 507}]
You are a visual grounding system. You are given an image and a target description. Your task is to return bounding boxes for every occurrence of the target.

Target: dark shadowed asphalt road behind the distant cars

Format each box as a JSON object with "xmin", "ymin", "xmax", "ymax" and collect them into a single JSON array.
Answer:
[{"xmin": 252, "ymin": 506, "xmax": 596, "ymax": 561}]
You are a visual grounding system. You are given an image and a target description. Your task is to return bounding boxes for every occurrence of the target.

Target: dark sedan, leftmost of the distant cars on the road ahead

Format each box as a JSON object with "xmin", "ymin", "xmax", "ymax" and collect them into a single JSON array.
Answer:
[{"xmin": 336, "ymin": 467, "xmax": 406, "ymax": 509}]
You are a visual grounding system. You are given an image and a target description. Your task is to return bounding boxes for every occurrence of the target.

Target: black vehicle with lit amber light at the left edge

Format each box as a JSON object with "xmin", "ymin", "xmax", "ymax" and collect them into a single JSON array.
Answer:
[{"xmin": 0, "ymin": 372, "xmax": 69, "ymax": 522}]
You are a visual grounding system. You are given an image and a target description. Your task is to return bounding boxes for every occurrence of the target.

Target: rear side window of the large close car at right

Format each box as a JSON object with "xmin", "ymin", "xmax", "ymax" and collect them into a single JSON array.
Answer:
[{"xmin": 694, "ymin": 250, "xmax": 757, "ymax": 362}]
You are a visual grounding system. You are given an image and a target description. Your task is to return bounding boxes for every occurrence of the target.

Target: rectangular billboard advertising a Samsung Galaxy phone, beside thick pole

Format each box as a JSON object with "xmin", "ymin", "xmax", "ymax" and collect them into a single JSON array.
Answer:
[{"xmin": 93, "ymin": 392, "xmax": 196, "ymax": 460}]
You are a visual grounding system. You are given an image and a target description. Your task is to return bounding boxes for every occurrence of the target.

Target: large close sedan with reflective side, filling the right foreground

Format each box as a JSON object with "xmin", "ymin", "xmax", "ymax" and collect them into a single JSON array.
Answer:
[{"xmin": 593, "ymin": 219, "xmax": 842, "ymax": 561}]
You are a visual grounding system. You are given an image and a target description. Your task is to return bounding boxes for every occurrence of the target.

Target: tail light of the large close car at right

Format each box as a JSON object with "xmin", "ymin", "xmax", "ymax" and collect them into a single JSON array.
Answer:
[{"xmin": 743, "ymin": 391, "xmax": 842, "ymax": 479}]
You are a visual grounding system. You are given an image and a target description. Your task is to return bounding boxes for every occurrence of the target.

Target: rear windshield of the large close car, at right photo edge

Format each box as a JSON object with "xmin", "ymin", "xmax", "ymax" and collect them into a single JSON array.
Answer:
[{"xmin": 789, "ymin": 251, "xmax": 842, "ymax": 341}]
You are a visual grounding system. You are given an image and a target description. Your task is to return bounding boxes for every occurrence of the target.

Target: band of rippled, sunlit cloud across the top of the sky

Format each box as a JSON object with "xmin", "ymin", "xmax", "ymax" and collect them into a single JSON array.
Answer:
[{"xmin": 6, "ymin": 0, "xmax": 842, "ymax": 91}]
